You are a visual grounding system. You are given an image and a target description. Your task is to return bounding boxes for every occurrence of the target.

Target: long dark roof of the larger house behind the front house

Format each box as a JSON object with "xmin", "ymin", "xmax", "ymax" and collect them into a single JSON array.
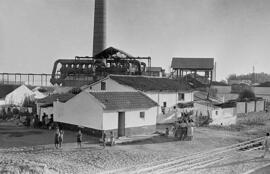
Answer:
[{"xmin": 110, "ymin": 75, "xmax": 190, "ymax": 91}]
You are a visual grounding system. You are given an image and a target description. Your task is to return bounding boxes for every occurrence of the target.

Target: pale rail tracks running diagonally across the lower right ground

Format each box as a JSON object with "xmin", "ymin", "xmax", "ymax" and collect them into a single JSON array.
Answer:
[{"xmin": 103, "ymin": 137, "xmax": 263, "ymax": 174}]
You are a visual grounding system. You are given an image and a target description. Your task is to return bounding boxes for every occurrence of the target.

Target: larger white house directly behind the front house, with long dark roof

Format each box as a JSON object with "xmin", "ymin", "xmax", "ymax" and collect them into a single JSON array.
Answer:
[{"xmin": 84, "ymin": 75, "xmax": 193, "ymax": 115}]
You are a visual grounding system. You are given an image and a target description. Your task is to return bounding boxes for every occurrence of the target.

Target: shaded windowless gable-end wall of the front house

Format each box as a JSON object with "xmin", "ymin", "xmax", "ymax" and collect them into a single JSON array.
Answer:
[{"xmin": 54, "ymin": 92, "xmax": 103, "ymax": 130}]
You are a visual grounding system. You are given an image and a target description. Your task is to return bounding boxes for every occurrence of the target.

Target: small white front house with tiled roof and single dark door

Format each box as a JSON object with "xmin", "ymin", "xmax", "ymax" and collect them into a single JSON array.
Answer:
[{"xmin": 53, "ymin": 91, "xmax": 158, "ymax": 137}]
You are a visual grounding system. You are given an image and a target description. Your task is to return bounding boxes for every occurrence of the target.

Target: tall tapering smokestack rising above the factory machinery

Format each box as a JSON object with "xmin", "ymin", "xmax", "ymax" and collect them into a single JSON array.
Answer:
[{"xmin": 93, "ymin": 0, "xmax": 106, "ymax": 56}]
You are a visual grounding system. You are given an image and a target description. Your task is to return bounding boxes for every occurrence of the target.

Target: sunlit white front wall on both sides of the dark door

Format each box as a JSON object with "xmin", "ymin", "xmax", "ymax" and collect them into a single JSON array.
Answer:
[{"xmin": 103, "ymin": 107, "xmax": 156, "ymax": 130}]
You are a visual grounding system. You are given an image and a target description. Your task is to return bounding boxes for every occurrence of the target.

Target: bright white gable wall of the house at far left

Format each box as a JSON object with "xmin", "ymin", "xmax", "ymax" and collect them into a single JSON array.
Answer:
[{"xmin": 5, "ymin": 85, "xmax": 34, "ymax": 106}]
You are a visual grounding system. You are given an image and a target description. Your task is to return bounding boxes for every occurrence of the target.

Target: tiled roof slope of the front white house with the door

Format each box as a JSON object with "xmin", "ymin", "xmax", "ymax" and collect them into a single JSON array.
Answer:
[{"xmin": 90, "ymin": 92, "xmax": 158, "ymax": 110}]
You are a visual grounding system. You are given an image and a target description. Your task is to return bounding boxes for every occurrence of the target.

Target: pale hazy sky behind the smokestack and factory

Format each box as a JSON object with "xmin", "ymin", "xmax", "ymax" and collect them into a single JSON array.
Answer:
[{"xmin": 0, "ymin": 0, "xmax": 270, "ymax": 80}]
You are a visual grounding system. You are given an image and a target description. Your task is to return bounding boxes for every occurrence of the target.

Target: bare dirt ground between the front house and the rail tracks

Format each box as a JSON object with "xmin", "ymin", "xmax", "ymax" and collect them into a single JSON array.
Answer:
[{"xmin": 0, "ymin": 114, "xmax": 270, "ymax": 173}]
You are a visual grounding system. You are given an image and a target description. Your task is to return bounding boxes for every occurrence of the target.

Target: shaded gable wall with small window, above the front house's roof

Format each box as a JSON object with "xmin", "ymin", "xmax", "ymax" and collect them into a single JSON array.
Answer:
[{"xmin": 85, "ymin": 78, "xmax": 137, "ymax": 92}]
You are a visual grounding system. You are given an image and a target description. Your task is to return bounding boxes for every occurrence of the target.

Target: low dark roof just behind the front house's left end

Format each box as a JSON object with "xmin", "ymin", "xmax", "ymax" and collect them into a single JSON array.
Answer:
[{"xmin": 37, "ymin": 93, "xmax": 75, "ymax": 104}]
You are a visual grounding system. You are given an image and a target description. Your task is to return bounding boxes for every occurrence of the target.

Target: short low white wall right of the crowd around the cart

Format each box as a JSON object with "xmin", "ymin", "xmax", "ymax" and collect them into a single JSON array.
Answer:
[{"xmin": 210, "ymin": 108, "xmax": 237, "ymax": 126}]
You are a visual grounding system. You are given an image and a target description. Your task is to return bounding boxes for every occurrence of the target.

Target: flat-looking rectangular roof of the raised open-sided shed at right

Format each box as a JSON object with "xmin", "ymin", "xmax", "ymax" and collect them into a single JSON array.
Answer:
[{"xmin": 171, "ymin": 58, "xmax": 214, "ymax": 69}]
